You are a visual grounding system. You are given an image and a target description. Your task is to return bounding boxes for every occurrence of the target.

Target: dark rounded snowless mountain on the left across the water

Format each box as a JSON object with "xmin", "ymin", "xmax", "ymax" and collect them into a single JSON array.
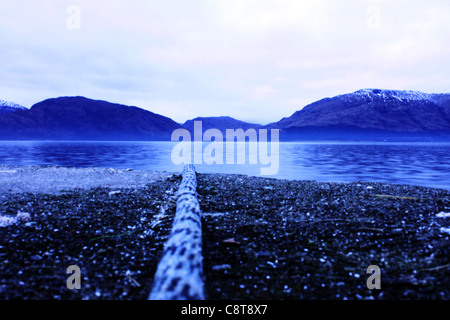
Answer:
[{"xmin": 0, "ymin": 97, "xmax": 181, "ymax": 140}]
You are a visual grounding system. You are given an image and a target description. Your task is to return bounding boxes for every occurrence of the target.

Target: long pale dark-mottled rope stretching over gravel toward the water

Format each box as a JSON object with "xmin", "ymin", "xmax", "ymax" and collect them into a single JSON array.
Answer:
[{"xmin": 149, "ymin": 165, "xmax": 204, "ymax": 300}]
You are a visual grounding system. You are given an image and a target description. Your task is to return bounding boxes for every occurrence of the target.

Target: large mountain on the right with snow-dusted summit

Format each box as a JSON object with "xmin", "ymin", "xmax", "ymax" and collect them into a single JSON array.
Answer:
[{"xmin": 267, "ymin": 89, "xmax": 450, "ymax": 140}]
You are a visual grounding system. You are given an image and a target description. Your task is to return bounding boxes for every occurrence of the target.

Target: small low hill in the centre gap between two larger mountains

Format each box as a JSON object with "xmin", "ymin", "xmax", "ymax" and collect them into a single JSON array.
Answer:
[{"xmin": 183, "ymin": 117, "xmax": 262, "ymax": 134}]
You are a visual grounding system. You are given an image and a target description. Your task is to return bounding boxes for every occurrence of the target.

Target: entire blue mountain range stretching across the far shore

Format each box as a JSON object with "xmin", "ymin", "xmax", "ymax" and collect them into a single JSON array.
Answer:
[{"xmin": 0, "ymin": 88, "xmax": 450, "ymax": 141}]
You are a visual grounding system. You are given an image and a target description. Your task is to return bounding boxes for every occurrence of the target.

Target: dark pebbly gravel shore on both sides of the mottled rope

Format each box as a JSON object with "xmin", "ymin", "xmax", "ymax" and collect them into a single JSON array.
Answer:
[{"xmin": 0, "ymin": 166, "xmax": 450, "ymax": 300}]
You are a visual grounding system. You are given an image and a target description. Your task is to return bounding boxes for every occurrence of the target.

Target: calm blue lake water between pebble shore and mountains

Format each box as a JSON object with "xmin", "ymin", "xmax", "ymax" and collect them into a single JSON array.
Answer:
[{"xmin": 0, "ymin": 141, "xmax": 450, "ymax": 189}]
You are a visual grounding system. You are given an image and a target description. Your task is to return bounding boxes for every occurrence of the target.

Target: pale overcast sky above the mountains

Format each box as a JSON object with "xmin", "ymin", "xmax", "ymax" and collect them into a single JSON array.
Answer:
[{"xmin": 0, "ymin": 0, "xmax": 450, "ymax": 124}]
